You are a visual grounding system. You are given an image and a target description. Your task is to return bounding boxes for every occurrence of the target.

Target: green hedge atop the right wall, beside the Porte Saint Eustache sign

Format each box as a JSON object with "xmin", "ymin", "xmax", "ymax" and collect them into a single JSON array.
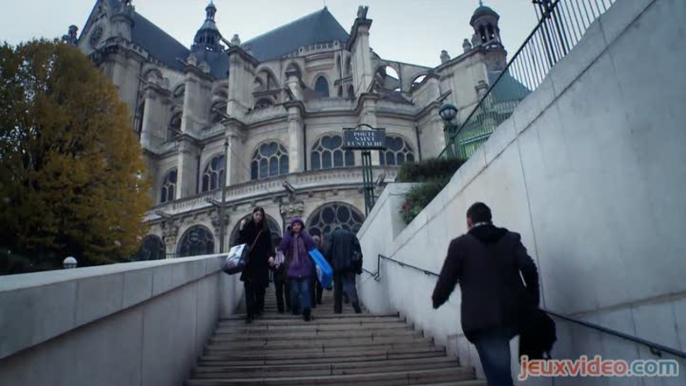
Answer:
[{"xmin": 397, "ymin": 158, "xmax": 465, "ymax": 224}]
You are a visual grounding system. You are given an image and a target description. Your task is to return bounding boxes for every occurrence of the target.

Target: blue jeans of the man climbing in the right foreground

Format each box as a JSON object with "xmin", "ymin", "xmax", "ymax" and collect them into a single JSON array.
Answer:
[{"xmin": 474, "ymin": 327, "xmax": 516, "ymax": 386}]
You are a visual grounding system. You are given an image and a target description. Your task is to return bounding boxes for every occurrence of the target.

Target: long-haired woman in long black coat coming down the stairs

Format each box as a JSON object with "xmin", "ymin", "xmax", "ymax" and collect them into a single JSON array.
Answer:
[{"xmin": 238, "ymin": 206, "xmax": 274, "ymax": 323}]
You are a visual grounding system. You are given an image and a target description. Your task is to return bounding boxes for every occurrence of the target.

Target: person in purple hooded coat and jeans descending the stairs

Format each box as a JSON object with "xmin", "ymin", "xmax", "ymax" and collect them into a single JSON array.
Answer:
[{"xmin": 279, "ymin": 218, "xmax": 316, "ymax": 322}]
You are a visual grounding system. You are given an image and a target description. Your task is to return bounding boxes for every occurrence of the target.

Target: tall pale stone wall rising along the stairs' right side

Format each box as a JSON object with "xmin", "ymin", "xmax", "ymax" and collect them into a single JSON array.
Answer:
[{"xmin": 359, "ymin": 0, "xmax": 686, "ymax": 385}]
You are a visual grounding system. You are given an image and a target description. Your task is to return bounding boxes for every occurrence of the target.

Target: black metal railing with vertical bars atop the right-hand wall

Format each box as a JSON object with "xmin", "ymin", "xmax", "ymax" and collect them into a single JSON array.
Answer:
[{"xmin": 439, "ymin": 0, "xmax": 616, "ymax": 159}]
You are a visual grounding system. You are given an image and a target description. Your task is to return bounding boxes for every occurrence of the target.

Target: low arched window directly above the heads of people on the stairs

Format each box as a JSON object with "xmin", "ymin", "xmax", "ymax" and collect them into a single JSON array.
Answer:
[{"xmin": 307, "ymin": 202, "xmax": 364, "ymax": 237}]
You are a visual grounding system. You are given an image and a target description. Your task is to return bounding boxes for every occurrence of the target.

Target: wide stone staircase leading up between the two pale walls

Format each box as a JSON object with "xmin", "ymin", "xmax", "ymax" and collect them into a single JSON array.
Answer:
[{"xmin": 185, "ymin": 286, "xmax": 486, "ymax": 386}]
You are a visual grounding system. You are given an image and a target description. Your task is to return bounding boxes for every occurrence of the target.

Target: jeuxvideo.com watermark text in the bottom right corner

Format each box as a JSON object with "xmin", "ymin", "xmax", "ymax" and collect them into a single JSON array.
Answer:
[{"xmin": 519, "ymin": 355, "xmax": 679, "ymax": 381}]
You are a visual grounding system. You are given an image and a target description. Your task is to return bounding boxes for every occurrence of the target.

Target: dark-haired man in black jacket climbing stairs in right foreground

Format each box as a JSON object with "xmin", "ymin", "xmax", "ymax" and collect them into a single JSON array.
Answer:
[{"xmin": 432, "ymin": 202, "xmax": 539, "ymax": 386}]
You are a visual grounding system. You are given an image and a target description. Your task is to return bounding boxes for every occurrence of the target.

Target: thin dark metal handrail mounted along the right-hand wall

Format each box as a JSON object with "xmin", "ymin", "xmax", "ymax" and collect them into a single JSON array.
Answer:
[{"xmin": 362, "ymin": 254, "xmax": 686, "ymax": 359}]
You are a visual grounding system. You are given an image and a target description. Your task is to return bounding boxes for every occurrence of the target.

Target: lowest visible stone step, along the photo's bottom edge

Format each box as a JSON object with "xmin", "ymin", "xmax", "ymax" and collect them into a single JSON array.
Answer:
[{"xmin": 186, "ymin": 367, "xmax": 474, "ymax": 386}]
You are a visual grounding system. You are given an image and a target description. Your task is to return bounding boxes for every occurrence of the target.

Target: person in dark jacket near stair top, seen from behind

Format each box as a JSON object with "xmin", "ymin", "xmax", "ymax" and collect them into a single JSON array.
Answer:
[{"xmin": 326, "ymin": 228, "xmax": 362, "ymax": 314}]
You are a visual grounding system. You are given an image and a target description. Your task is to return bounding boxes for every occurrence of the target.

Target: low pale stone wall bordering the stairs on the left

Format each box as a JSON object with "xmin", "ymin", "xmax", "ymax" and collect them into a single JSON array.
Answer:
[{"xmin": 0, "ymin": 255, "xmax": 242, "ymax": 386}]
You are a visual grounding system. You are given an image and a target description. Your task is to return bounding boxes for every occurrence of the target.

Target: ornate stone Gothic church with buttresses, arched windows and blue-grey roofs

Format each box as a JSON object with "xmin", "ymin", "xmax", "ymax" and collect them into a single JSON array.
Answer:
[{"xmin": 64, "ymin": 0, "xmax": 507, "ymax": 259}]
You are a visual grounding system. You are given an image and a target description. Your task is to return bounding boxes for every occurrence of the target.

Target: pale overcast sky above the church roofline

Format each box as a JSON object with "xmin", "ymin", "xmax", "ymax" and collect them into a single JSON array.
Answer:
[{"xmin": 0, "ymin": 0, "xmax": 536, "ymax": 66}]
